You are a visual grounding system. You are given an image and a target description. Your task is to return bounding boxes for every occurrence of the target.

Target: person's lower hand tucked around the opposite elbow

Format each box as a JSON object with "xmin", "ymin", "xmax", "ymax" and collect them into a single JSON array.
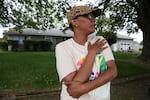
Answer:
[{"xmin": 65, "ymin": 81, "xmax": 84, "ymax": 98}]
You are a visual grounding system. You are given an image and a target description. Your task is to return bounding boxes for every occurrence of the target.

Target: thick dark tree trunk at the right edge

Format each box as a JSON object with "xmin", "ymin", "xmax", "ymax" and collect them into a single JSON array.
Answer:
[{"xmin": 138, "ymin": 0, "xmax": 150, "ymax": 60}]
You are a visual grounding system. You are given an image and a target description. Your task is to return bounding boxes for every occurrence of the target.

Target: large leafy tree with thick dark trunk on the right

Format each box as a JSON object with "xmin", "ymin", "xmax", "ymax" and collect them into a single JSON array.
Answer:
[{"xmin": 96, "ymin": 0, "xmax": 150, "ymax": 60}]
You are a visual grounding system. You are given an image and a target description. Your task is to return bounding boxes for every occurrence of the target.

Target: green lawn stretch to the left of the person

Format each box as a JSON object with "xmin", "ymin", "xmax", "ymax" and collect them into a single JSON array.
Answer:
[{"xmin": 0, "ymin": 52, "xmax": 60, "ymax": 89}]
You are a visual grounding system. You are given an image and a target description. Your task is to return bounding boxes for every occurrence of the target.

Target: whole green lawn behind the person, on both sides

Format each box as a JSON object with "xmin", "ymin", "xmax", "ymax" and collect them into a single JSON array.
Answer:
[{"xmin": 0, "ymin": 52, "xmax": 150, "ymax": 90}]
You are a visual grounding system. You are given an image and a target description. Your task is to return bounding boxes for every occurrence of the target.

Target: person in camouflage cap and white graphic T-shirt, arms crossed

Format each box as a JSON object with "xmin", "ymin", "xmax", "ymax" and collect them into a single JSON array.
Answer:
[{"xmin": 55, "ymin": 5, "xmax": 117, "ymax": 100}]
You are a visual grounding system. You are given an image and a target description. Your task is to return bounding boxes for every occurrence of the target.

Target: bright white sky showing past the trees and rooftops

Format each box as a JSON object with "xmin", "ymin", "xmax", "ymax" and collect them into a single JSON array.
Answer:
[{"xmin": 0, "ymin": 0, "xmax": 143, "ymax": 43}]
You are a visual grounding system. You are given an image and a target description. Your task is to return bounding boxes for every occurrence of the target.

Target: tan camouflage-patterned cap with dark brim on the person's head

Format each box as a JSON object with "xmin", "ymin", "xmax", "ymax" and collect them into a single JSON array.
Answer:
[{"xmin": 67, "ymin": 6, "xmax": 101, "ymax": 24}]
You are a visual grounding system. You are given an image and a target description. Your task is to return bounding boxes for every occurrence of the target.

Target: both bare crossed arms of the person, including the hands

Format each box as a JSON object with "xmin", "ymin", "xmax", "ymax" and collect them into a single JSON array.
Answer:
[{"xmin": 62, "ymin": 38, "xmax": 117, "ymax": 98}]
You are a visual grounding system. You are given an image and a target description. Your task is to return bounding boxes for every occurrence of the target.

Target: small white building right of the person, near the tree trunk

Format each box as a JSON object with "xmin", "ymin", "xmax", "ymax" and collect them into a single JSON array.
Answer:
[{"xmin": 111, "ymin": 34, "xmax": 140, "ymax": 52}]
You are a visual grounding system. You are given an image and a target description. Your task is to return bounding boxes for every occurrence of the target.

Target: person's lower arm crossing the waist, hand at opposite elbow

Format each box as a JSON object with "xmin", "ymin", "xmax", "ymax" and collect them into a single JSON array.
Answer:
[{"xmin": 64, "ymin": 60, "xmax": 117, "ymax": 98}]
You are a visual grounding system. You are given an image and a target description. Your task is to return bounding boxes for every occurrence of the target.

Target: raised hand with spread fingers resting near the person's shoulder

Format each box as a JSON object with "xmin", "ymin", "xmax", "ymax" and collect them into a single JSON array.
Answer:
[{"xmin": 88, "ymin": 39, "xmax": 107, "ymax": 54}]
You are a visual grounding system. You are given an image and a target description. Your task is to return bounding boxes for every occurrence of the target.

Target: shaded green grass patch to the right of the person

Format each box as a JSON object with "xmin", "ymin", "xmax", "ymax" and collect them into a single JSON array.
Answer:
[{"xmin": 114, "ymin": 52, "xmax": 150, "ymax": 78}]
